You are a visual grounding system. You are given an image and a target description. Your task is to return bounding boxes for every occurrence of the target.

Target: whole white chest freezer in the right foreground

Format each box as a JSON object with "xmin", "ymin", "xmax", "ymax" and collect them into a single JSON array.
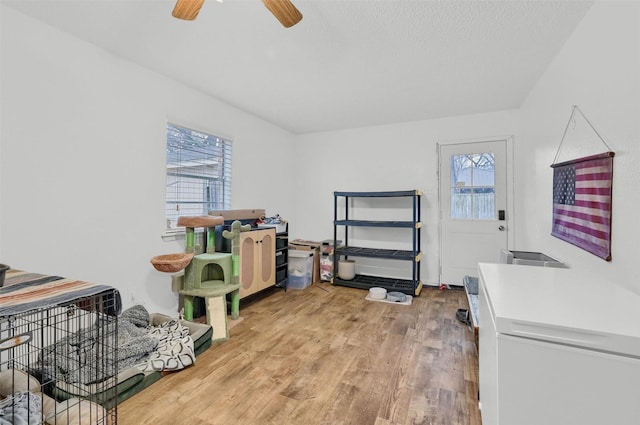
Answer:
[{"xmin": 478, "ymin": 264, "xmax": 640, "ymax": 425}]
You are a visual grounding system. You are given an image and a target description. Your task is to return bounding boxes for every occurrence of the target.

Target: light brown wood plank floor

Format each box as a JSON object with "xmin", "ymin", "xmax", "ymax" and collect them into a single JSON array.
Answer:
[{"xmin": 118, "ymin": 283, "xmax": 481, "ymax": 425}]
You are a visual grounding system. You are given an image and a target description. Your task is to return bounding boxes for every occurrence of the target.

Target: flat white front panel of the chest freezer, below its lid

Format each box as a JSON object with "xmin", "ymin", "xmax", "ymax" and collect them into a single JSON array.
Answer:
[{"xmin": 500, "ymin": 334, "xmax": 640, "ymax": 425}]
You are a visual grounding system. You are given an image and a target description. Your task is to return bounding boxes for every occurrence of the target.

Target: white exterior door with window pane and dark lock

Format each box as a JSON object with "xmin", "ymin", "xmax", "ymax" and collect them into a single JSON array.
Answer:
[{"xmin": 438, "ymin": 140, "xmax": 509, "ymax": 285}]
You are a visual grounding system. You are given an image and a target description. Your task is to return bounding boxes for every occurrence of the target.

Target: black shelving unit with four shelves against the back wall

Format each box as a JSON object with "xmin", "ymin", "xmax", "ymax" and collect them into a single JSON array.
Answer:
[{"xmin": 332, "ymin": 190, "xmax": 422, "ymax": 295}]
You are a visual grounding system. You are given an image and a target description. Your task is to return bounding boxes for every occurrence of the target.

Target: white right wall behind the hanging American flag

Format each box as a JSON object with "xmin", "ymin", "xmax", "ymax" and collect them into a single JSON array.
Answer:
[{"xmin": 516, "ymin": 2, "xmax": 640, "ymax": 293}]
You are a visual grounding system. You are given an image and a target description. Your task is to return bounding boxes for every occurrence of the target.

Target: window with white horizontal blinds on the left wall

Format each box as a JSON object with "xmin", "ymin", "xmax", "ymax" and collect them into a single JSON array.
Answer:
[{"xmin": 166, "ymin": 123, "xmax": 232, "ymax": 230}]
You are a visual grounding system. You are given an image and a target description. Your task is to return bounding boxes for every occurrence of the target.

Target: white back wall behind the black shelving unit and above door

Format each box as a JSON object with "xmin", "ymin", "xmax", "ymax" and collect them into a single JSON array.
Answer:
[{"xmin": 290, "ymin": 110, "xmax": 518, "ymax": 285}]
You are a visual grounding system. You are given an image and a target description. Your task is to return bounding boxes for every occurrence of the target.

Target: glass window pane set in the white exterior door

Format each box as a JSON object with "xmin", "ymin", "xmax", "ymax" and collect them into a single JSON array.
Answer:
[{"xmin": 451, "ymin": 153, "xmax": 496, "ymax": 220}]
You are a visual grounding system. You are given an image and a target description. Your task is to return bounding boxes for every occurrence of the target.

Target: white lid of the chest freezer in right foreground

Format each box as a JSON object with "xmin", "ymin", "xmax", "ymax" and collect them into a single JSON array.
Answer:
[{"xmin": 478, "ymin": 263, "xmax": 640, "ymax": 358}]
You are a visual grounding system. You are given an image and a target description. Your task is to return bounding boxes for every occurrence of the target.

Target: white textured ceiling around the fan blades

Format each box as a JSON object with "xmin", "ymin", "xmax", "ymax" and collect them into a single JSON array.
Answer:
[{"xmin": 2, "ymin": 0, "xmax": 591, "ymax": 133}]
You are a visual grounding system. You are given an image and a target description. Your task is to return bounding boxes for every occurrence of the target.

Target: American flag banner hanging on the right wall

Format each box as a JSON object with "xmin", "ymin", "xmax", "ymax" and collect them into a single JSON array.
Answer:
[{"xmin": 551, "ymin": 152, "xmax": 615, "ymax": 261}]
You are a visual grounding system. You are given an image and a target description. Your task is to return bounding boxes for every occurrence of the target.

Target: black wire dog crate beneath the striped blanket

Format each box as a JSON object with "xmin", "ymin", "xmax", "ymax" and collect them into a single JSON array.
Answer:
[{"xmin": 0, "ymin": 290, "xmax": 119, "ymax": 425}]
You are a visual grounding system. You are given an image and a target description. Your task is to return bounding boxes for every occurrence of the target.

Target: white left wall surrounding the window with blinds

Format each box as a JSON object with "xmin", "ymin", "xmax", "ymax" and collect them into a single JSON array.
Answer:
[{"xmin": 0, "ymin": 6, "xmax": 294, "ymax": 314}]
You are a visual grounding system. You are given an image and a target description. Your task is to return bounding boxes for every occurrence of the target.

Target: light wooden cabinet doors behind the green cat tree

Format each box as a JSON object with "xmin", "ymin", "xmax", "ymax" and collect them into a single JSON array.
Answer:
[{"xmin": 240, "ymin": 229, "xmax": 276, "ymax": 298}]
